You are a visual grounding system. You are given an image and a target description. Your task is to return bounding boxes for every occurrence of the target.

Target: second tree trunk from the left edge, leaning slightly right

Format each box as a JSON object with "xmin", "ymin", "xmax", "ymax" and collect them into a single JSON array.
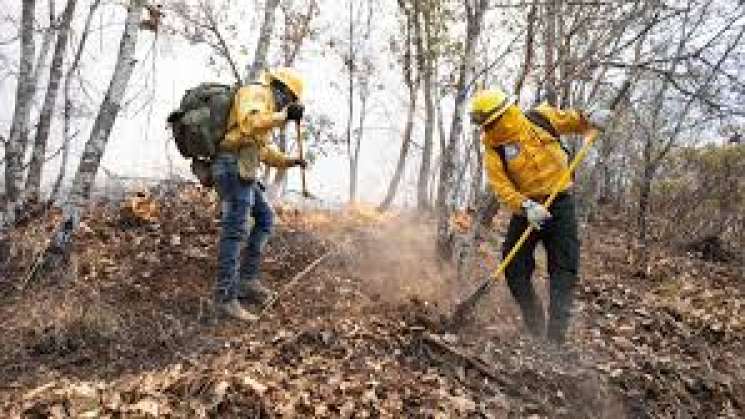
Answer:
[{"xmin": 25, "ymin": 0, "xmax": 77, "ymax": 201}]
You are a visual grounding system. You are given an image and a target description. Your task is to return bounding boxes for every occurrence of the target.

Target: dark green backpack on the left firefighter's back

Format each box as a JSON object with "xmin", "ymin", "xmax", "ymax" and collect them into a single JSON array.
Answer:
[{"xmin": 167, "ymin": 83, "xmax": 238, "ymax": 186}]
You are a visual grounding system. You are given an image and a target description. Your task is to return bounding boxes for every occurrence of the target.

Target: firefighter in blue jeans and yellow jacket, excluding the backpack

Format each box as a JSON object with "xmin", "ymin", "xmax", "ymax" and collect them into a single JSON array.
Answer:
[{"xmin": 212, "ymin": 68, "xmax": 306, "ymax": 321}]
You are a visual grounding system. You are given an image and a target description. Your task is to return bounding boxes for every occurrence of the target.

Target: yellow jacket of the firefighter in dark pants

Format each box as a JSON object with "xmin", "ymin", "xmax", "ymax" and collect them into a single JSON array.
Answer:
[{"xmin": 482, "ymin": 103, "xmax": 591, "ymax": 213}]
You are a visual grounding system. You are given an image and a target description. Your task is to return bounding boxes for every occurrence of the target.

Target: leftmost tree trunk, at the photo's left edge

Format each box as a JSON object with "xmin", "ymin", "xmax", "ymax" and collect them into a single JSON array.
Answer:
[{"xmin": 5, "ymin": 0, "xmax": 36, "ymax": 213}]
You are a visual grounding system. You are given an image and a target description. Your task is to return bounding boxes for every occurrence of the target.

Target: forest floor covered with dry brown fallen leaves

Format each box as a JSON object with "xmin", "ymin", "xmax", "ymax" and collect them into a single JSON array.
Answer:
[{"xmin": 0, "ymin": 188, "xmax": 745, "ymax": 418}]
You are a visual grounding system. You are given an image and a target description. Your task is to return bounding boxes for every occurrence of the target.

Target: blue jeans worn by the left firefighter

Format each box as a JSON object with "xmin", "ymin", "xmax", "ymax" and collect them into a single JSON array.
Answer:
[{"xmin": 212, "ymin": 154, "xmax": 273, "ymax": 302}]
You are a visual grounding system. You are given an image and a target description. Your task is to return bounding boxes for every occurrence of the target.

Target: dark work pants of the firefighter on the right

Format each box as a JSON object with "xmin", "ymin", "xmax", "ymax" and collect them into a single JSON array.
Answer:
[{"xmin": 502, "ymin": 194, "xmax": 579, "ymax": 343}]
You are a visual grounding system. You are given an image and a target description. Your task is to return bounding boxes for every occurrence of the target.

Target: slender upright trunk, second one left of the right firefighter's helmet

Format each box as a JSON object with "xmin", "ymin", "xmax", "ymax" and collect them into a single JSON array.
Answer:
[{"xmin": 417, "ymin": 2, "xmax": 435, "ymax": 210}]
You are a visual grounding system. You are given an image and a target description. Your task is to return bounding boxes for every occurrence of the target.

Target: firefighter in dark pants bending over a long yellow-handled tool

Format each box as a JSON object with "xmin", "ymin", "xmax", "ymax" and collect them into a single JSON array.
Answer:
[{"xmin": 470, "ymin": 89, "xmax": 610, "ymax": 344}]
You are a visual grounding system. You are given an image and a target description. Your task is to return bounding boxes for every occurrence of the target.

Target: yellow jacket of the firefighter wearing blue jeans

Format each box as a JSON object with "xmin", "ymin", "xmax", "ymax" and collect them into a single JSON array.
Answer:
[{"xmin": 220, "ymin": 83, "xmax": 293, "ymax": 180}]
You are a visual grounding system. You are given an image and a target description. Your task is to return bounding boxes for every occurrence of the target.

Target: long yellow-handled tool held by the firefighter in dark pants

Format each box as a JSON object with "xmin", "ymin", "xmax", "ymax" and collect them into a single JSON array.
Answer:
[{"xmin": 450, "ymin": 129, "xmax": 600, "ymax": 329}]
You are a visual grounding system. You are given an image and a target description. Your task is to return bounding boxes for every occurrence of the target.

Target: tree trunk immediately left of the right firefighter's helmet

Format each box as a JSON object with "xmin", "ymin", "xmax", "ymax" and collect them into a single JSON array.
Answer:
[{"xmin": 437, "ymin": 0, "xmax": 488, "ymax": 259}]
